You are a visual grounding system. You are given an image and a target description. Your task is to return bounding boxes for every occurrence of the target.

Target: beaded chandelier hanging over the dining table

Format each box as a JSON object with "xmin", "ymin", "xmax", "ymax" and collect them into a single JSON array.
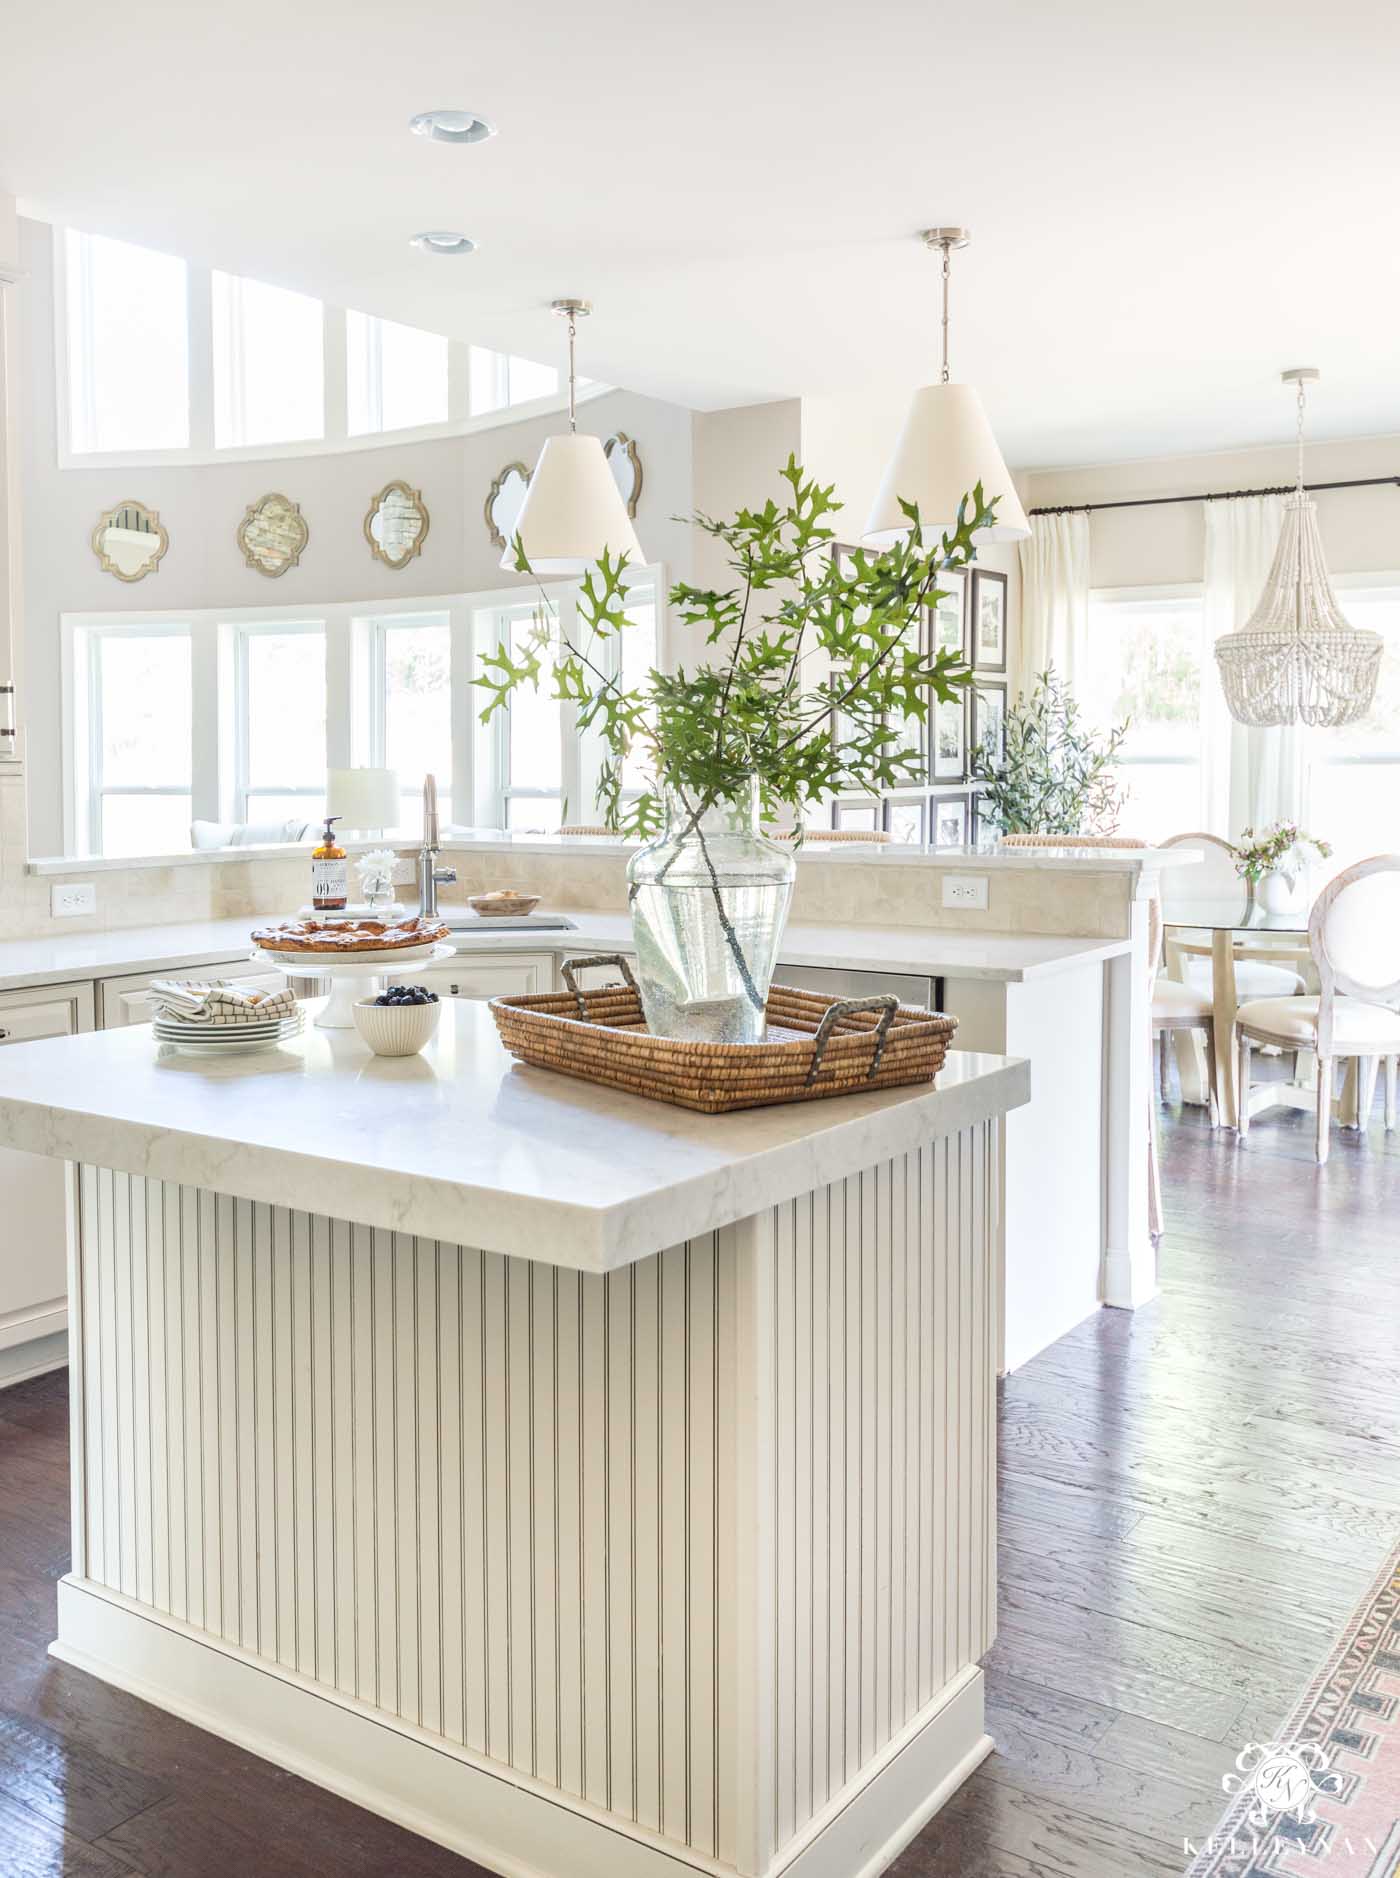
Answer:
[{"xmin": 1216, "ymin": 366, "xmax": 1385, "ymax": 727}]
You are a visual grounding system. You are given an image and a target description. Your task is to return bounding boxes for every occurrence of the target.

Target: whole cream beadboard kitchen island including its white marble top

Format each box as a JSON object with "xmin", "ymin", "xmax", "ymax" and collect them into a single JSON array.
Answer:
[{"xmin": 0, "ymin": 1005, "xmax": 1030, "ymax": 1878}]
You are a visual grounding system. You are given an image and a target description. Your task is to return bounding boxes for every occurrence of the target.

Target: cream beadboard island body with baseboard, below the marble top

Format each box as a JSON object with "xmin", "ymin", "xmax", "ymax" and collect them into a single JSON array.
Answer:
[{"xmin": 54, "ymin": 1141, "xmax": 1000, "ymax": 1878}]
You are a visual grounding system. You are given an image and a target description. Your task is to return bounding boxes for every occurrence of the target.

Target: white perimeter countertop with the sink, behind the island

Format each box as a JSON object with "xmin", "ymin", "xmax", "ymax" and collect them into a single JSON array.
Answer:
[{"xmin": 0, "ymin": 911, "xmax": 1131, "ymax": 992}]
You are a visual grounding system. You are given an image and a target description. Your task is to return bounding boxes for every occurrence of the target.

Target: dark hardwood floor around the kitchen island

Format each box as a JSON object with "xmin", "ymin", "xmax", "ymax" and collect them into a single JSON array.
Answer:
[{"xmin": 0, "ymin": 1110, "xmax": 1400, "ymax": 1878}]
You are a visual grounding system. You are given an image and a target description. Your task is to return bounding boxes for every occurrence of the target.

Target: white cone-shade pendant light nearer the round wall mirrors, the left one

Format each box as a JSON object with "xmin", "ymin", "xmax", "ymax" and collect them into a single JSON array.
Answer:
[{"xmin": 500, "ymin": 300, "xmax": 646, "ymax": 575}]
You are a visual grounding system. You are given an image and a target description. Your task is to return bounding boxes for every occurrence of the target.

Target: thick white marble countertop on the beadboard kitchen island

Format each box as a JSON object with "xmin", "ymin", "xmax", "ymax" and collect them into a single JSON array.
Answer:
[{"xmin": 0, "ymin": 1001, "xmax": 1030, "ymax": 1271}]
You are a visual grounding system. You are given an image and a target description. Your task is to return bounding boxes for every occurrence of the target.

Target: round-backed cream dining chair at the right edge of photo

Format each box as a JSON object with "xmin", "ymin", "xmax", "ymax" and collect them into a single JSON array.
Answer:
[{"xmin": 1235, "ymin": 854, "xmax": 1400, "ymax": 1166}]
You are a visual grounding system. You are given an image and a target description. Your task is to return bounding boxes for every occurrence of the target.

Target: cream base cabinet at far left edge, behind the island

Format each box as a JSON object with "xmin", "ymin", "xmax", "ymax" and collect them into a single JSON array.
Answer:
[{"xmin": 0, "ymin": 984, "xmax": 94, "ymax": 1386}]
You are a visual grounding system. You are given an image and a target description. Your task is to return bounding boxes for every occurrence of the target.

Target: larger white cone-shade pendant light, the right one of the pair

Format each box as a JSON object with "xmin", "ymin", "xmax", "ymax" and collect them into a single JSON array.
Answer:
[{"xmin": 863, "ymin": 229, "xmax": 1030, "ymax": 548}]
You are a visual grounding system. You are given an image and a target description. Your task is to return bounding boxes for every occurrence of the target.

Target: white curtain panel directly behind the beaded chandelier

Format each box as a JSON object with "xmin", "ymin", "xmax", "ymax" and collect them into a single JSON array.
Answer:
[{"xmin": 1201, "ymin": 496, "xmax": 1306, "ymax": 839}]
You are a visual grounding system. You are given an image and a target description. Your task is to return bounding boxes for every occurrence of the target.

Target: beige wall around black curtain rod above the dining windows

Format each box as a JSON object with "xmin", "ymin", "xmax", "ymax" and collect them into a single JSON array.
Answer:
[{"xmin": 1024, "ymin": 438, "xmax": 1400, "ymax": 588}]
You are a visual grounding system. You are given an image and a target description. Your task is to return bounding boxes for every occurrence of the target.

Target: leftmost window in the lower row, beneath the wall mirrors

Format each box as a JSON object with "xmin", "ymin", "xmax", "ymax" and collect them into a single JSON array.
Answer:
[{"xmin": 81, "ymin": 625, "xmax": 192, "ymax": 856}]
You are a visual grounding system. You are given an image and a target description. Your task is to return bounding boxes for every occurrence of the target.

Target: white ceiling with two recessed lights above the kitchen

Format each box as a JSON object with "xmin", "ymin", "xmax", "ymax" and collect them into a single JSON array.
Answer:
[{"xmin": 0, "ymin": 0, "xmax": 1400, "ymax": 468}]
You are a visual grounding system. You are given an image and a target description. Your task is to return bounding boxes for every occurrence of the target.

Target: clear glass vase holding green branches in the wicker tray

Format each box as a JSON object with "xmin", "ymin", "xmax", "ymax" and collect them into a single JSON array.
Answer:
[{"xmin": 628, "ymin": 781, "xmax": 797, "ymax": 1044}]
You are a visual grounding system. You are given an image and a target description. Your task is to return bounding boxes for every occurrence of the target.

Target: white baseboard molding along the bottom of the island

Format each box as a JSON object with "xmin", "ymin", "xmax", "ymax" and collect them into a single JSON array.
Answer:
[{"xmin": 49, "ymin": 1578, "xmax": 992, "ymax": 1878}]
